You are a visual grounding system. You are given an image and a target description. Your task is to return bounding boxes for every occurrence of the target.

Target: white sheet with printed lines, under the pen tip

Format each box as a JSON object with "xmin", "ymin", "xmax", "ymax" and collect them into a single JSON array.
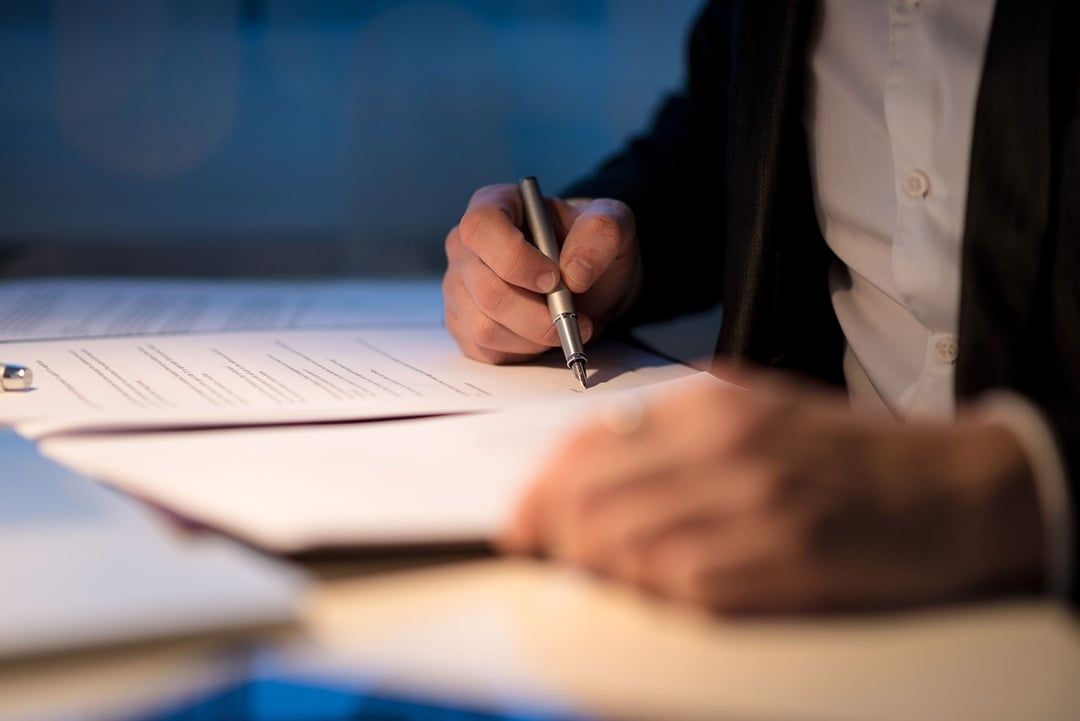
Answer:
[{"xmin": 0, "ymin": 328, "xmax": 692, "ymax": 437}]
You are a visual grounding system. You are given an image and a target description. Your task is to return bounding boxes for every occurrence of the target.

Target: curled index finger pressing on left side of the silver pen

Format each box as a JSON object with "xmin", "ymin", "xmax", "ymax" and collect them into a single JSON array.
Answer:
[{"xmin": 458, "ymin": 185, "xmax": 558, "ymax": 293}]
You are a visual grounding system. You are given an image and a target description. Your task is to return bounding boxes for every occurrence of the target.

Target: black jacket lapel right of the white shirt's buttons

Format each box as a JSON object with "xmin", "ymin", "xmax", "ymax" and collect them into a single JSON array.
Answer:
[{"xmin": 956, "ymin": 0, "xmax": 1049, "ymax": 397}]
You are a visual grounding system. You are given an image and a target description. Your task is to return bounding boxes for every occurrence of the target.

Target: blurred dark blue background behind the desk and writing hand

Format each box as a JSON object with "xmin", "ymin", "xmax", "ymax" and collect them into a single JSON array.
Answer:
[{"xmin": 0, "ymin": 0, "xmax": 699, "ymax": 275}]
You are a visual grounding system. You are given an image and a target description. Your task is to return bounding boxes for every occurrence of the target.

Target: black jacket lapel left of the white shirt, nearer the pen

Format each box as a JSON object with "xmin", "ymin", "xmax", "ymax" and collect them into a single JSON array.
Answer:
[{"xmin": 717, "ymin": 0, "xmax": 842, "ymax": 379}]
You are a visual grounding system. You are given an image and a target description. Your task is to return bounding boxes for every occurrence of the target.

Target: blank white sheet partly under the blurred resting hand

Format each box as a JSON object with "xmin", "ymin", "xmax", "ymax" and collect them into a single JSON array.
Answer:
[{"xmin": 42, "ymin": 373, "xmax": 720, "ymax": 553}]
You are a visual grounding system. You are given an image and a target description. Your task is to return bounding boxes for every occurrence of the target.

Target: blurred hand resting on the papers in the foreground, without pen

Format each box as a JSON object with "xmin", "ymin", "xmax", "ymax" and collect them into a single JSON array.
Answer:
[{"xmin": 503, "ymin": 376, "xmax": 1042, "ymax": 613}]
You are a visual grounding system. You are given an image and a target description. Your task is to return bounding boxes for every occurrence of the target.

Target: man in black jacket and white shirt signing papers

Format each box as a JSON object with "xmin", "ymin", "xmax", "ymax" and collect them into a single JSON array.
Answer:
[{"xmin": 444, "ymin": 0, "xmax": 1080, "ymax": 612}]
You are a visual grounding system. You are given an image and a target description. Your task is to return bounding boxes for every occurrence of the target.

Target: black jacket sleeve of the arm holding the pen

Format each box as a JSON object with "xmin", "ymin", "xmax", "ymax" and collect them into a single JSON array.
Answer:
[{"xmin": 563, "ymin": 2, "xmax": 731, "ymax": 323}]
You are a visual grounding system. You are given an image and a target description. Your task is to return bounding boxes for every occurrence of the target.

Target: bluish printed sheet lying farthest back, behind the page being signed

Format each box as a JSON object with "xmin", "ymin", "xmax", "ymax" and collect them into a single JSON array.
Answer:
[{"xmin": 0, "ymin": 278, "xmax": 443, "ymax": 342}]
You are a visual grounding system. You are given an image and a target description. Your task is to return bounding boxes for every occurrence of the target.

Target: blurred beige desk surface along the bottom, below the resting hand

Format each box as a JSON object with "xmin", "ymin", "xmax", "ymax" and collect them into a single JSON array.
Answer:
[{"xmin": 0, "ymin": 558, "xmax": 1080, "ymax": 721}]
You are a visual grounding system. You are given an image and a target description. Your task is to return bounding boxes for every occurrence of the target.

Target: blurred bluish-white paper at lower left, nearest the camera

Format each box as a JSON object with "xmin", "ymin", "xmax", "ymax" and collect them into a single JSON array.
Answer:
[{"xmin": 0, "ymin": 431, "xmax": 306, "ymax": 660}]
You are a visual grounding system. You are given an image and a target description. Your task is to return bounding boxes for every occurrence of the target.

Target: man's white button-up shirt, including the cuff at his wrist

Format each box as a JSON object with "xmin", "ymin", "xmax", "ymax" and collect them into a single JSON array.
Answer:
[{"xmin": 806, "ymin": 0, "xmax": 1071, "ymax": 590}]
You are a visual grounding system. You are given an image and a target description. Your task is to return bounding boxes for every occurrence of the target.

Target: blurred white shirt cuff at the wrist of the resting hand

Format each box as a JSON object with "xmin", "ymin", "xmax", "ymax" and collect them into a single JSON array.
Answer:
[{"xmin": 973, "ymin": 391, "xmax": 1075, "ymax": 597}]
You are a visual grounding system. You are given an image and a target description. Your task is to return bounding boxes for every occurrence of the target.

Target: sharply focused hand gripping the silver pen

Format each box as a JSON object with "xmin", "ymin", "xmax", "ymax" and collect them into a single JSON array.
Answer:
[{"xmin": 443, "ymin": 185, "xmax": 640, "ymax": 363}]
